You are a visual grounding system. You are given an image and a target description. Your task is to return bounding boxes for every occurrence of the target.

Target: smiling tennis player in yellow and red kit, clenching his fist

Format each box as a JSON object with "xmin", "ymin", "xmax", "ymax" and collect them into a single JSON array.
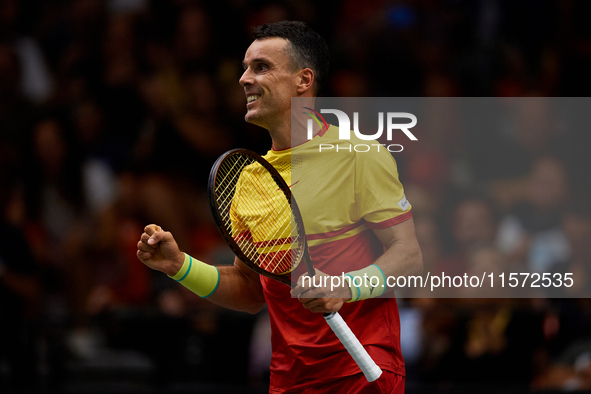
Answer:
[{"xmin": 137, "ymin": 22, "xmax": 422, "ymax": 393}]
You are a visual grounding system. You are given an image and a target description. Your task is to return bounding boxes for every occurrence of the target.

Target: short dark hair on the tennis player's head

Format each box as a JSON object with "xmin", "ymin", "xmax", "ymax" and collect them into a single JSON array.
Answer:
[{"xmin": 253, "ymin": 21, "xmax": 329, "ymax": 95}]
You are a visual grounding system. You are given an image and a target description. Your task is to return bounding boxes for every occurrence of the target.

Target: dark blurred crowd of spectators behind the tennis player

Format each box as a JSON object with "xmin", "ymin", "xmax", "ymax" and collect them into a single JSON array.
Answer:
[{"xmin": 0, "ymin": 0, "xmax": 591, "ymax": 393}]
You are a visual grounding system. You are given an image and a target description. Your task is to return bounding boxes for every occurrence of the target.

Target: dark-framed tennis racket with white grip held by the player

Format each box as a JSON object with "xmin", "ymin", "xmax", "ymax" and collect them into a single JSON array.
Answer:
[{"xmin": 208, "ymin": 149, "xmax": 382, "ymax": 382}]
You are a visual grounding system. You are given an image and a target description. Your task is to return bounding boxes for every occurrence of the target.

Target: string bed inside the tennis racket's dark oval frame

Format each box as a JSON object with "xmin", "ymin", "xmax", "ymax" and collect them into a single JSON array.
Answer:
[{"xmin": 216, "ymin": 155, "xmax": 301, "ymax": 274}]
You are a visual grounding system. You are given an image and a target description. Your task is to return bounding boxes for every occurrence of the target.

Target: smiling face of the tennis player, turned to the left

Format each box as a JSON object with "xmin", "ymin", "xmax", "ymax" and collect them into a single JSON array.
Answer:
[{"xmin": 240, "ymin": 37, "xmax": 298, "ymax": 129}]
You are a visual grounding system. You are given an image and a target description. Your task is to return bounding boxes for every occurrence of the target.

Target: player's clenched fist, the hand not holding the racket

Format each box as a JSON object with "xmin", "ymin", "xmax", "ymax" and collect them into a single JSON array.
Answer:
[{"xmin": 137, "ymin": 224, "xmax": 185, "ymax": 276}]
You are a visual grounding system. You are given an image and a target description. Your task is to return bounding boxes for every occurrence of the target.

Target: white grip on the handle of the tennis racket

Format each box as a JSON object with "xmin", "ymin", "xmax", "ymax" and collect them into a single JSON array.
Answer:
[{"xmin": 324, "ymin": 312, "xmax": 382, "ymax": 382}]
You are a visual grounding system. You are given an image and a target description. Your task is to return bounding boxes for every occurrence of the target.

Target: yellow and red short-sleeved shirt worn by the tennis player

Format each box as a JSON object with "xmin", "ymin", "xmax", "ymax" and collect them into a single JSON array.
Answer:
[{"xmin": 236, "ymin": 126, "xmax": 412, "ymax": 392}]
